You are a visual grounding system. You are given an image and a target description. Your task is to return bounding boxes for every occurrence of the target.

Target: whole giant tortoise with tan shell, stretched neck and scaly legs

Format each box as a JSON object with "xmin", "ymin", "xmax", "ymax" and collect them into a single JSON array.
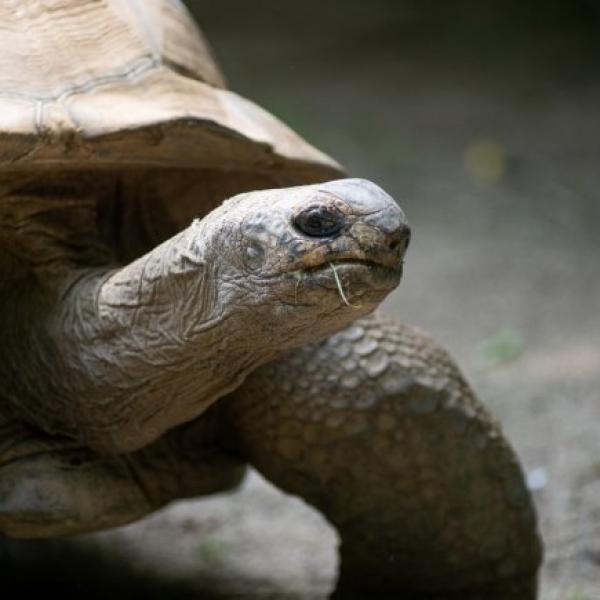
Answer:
[{"xmin": 0, "ymin": 0, "xmax": 541, "ymax": 599}]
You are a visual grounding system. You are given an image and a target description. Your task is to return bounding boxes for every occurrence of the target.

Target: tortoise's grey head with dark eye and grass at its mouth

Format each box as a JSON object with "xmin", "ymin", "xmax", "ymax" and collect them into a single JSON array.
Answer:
[{"xmin": 204, "ymin": 179, "xmax": 410, "ymax": 318}]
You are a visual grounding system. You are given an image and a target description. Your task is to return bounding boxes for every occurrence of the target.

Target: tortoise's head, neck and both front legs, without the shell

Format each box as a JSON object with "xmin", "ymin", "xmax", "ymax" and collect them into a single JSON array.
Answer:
[{"xmin": 0, "ymin": 180, "xmax": 541, "ymax": 600}]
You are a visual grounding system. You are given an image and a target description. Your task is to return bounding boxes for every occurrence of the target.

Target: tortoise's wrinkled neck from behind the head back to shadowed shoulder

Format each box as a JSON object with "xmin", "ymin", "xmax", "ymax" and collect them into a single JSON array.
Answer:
[{"xmin": 0, "ymin": 180, "xmax": 273, "ymax": 452}]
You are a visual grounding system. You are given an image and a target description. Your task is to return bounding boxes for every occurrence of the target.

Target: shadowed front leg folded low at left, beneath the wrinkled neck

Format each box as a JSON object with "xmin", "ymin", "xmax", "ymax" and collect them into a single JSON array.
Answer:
[{"xmin": 0, "ymin": 408, "xmax": 246, "ymax": 539}]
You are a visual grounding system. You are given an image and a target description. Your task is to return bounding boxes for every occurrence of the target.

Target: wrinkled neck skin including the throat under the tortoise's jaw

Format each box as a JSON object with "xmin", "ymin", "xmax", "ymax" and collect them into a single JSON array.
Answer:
[{"xmin": 2, "ymin": 192, "xmax": 381, "ymax": 452}]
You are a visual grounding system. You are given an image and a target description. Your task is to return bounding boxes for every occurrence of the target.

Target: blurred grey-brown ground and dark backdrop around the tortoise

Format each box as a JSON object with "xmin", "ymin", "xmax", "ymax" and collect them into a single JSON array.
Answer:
[{"xmin": 2, "ymin": 0, "xmax": 600, "ymax": 600}]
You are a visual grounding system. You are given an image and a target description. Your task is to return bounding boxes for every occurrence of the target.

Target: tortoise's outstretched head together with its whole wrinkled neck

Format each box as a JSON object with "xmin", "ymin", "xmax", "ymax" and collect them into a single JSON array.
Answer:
[{"xmin": 0, "ymin": 178, "xmax": 409, "ymax": 454}]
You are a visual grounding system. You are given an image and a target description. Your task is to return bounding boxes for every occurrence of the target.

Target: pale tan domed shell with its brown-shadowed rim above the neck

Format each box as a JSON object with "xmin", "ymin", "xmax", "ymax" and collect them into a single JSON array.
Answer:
[{"xmin": 0, "ymin": 0, "xmax": 338, "ymax": 173}]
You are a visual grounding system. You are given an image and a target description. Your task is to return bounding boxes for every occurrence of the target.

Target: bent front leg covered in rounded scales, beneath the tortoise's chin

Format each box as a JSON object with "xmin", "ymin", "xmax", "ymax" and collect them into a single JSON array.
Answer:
[{"xmin": 228, "ymin": 317, "xmax": 541, "ymax": 600}]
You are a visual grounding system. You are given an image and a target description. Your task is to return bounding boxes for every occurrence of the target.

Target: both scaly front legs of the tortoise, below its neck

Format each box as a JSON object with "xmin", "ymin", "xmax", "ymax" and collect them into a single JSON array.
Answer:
[{"xmin": 0, "ymin": 316, "xmax": 541, "ymax": 600}]
